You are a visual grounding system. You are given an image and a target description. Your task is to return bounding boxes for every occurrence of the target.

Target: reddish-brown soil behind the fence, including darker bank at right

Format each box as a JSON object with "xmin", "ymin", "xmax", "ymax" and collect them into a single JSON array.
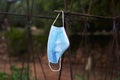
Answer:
[{"xmin": 0, "ymin": 38, "xmax": 120, "ymax": 80}]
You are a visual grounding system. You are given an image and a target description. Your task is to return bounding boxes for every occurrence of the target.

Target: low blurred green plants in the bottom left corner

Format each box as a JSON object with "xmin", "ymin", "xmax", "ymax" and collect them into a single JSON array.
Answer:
[{"xmin": 0, "ymin": 65, "xmax": 28, "ymax": 80}]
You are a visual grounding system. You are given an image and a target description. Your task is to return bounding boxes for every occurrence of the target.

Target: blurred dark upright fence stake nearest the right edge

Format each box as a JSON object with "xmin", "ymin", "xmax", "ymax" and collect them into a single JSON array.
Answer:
[{"xmin": 105, "ymin": 19, "xmax": 118, "ymax": 80}]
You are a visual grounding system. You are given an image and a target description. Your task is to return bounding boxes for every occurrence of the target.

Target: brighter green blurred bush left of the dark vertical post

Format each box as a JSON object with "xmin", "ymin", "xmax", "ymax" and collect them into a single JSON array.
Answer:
[{"xmin": 5, "ymin": 27, "xmax": 27, "ymax": 56}]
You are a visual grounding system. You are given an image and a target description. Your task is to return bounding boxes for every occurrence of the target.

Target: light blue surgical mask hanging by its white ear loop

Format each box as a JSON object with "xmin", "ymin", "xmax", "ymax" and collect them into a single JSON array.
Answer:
[{"xmin": 47, "ymin": 11, "xmax": 70, "ymax": 71}]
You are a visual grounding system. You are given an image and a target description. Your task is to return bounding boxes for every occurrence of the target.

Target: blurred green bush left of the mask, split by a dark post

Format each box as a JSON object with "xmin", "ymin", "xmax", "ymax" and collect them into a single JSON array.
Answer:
[{"xmin": 5, "ymin": 27, "xmax": 48, "ymax": 56}]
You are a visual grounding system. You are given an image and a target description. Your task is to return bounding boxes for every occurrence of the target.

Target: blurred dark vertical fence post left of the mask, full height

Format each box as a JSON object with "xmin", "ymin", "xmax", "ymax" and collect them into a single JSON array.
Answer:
[{"xmin": 21, "ymin": 0, "xmax": 37, "ymax": 80}]
